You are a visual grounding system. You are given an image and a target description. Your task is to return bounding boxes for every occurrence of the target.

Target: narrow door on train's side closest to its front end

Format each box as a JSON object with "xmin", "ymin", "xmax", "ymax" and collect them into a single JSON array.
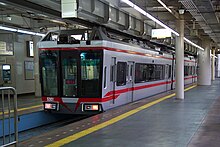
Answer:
[{"xmin": 110, "ymin": 57, "xmax": 116, "ymax": 104}]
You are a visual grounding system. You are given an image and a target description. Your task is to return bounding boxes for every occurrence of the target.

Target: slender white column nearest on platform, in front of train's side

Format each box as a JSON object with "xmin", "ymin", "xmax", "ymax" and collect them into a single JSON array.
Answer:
[{"xmin": 175, "ymin": 19, "xmax": 184, "ymax": 99}]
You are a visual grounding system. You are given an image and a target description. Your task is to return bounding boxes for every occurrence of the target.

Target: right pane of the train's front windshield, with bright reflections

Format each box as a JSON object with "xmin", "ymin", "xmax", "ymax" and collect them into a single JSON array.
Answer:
[{"xmin": 80, "ymin": 51, "xmax": 101, "ymax": 97}]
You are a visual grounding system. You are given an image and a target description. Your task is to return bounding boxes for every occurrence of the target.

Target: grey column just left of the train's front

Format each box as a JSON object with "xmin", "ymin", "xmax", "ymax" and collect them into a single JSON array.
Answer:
[{"xmin": 33, "ymin": 36, "xmax": 41, "ymax": 97}]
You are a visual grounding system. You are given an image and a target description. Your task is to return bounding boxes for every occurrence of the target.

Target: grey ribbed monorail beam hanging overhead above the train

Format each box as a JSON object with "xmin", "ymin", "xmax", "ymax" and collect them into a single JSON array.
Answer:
[{"xmin": 61, "ymin": 0, "xmax": 151, "ymax": 36}]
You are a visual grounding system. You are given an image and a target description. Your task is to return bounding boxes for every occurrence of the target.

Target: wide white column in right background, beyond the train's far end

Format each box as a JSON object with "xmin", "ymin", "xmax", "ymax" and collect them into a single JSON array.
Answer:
[{"xmin": 198, "ymin": 39, "xmax": 211, "ymax": 85}]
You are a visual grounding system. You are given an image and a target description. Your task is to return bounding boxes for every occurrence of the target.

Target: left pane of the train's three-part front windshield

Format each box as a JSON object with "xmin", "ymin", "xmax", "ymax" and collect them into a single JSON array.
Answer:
[{"xmin": 40, "ymin": 51, "xmax": 58, "ymax": 96}]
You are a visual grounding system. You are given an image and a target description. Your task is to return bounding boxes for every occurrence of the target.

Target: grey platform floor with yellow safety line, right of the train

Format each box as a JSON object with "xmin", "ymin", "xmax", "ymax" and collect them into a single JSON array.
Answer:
[{"xmin": 19, "ymin": 79, "xmax": 220, "ymax": 147}]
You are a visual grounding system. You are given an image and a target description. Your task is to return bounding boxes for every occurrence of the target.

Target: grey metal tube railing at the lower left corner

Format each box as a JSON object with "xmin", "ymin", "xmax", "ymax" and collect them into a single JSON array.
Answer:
[{"xmin": 0, "ymin": 87, "xmax": 18, "ymax": 147}]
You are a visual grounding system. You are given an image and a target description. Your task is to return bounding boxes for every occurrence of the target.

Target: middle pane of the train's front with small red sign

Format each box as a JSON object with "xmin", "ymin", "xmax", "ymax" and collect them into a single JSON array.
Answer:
[{"xmin": 62, "ymin": 57, "xmax": 77, "ymax": 97}]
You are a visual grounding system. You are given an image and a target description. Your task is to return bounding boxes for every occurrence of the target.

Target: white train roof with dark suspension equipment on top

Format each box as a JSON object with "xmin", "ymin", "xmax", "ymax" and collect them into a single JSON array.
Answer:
[{"xmin": 38, "ymin": 27, "xmax": 196, "ymax": 59}]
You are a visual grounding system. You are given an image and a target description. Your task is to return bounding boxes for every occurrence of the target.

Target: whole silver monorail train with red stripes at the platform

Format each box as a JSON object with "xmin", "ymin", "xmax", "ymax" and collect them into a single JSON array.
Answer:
[{"xmin": 38, "ymin": 28, "xmax": 197, "ymax": 114}]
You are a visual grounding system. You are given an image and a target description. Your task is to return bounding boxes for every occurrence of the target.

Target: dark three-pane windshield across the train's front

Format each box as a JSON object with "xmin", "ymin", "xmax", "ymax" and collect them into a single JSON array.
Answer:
[{"xmin": 40, "ymin": 50, "xmax": 102, "ymax": 98}]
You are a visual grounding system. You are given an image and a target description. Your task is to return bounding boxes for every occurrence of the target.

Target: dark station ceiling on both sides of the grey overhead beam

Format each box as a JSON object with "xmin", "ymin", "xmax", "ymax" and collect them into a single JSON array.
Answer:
[{"xmin": 0, "ymin": 0, "xmax": 220, "ymax": 47}]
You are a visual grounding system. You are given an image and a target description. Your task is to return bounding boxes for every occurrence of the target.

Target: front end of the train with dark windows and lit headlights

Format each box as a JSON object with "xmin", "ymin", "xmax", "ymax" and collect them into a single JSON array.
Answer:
[{"xmin": 39, "ymin": 30, "xmax": 103, "ymax": 114}]
